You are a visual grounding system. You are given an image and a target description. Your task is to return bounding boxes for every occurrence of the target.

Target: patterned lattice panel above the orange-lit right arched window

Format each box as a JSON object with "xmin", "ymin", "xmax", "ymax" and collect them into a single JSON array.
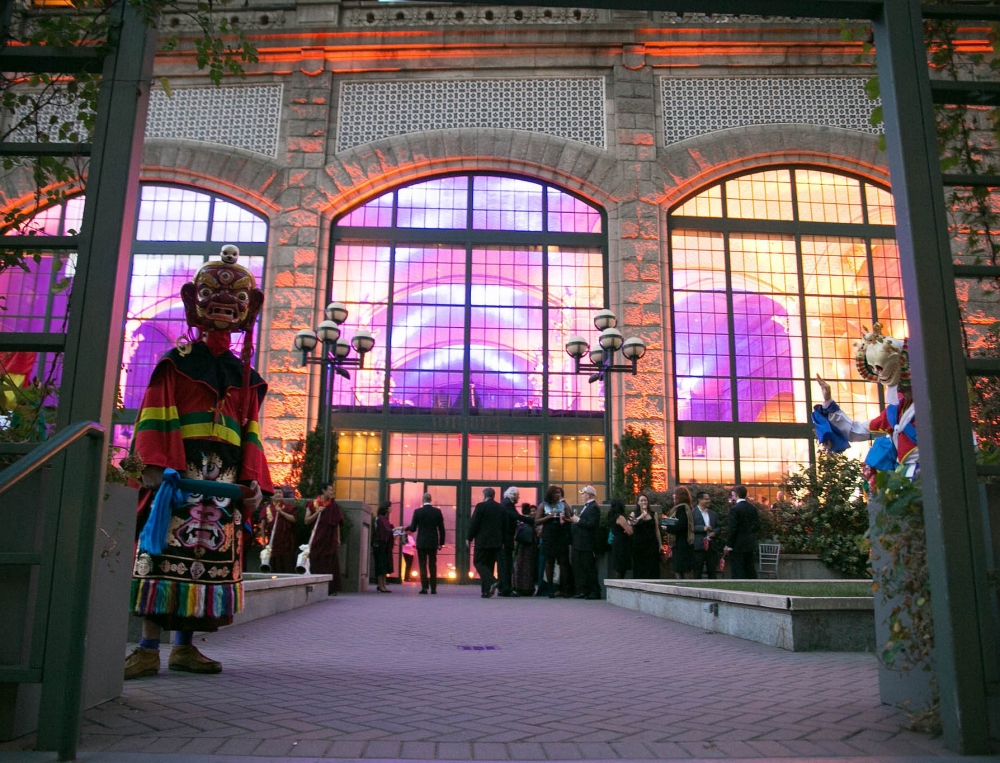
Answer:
[{"xmin": 660, "ymin": 77, "xmax": 881, "ymax": 145}]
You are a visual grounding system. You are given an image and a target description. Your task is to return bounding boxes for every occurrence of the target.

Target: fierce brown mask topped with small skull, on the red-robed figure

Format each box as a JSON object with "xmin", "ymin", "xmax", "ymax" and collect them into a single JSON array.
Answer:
[{"xmin": 181, "ymin": 244, "xmax": 264, "ymax": 331}]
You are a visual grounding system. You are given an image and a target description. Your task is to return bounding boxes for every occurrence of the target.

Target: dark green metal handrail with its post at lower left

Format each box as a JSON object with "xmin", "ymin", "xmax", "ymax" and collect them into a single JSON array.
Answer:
[{"xmin": 0, "ymin": 421, "xmax": 107, "ymax": 760}]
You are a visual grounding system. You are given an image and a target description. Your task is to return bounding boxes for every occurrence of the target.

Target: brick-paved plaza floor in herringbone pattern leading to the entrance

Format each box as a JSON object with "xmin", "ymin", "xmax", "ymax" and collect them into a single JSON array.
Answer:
[{"xmin": 0, "ymin": 585, "xmax": 960, "ymax": 761}]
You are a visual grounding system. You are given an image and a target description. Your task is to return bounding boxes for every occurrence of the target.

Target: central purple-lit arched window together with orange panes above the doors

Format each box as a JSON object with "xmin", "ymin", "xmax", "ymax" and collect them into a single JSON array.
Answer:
[{"xmin": 329, "ymin": 174, "xmax": 607, "ymax": 500}]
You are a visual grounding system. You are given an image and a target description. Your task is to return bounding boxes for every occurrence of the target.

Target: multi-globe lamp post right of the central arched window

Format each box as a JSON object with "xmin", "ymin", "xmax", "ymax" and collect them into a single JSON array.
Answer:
[{"xmin": 566, "ymin": 310, "xmax": 646, "ymax": 498}]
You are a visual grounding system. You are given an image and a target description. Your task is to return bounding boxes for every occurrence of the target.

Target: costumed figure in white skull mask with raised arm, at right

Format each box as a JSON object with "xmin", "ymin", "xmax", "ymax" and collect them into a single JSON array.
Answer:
[{"xmin": 812, "ymin": 323, "xmax": 920, "ymax": 484}]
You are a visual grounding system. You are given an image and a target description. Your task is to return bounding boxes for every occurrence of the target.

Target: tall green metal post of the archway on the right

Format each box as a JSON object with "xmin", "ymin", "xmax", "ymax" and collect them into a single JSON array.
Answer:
[{"xmin": 874, "ymin": 0, "xmax": 990, "ymax": 754}]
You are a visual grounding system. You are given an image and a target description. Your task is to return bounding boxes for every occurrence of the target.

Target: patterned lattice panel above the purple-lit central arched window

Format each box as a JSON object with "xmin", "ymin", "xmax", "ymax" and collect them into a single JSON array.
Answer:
[{"xmin": 337, "ymin": 77, "xmax": 605, "ymax": 151}]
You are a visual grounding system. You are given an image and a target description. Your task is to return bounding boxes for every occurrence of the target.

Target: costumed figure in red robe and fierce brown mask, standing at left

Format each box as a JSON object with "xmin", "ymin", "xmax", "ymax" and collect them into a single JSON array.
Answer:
[{"xmin": 125, "ymin": 245, "xmax": 274, "ymax": 679}]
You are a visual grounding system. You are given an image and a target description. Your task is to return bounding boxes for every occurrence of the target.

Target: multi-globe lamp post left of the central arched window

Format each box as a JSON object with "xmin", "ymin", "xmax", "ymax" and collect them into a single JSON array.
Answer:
[{"xmin": 295, "ymin": 302, "xmax": 375, "ymax": 482}]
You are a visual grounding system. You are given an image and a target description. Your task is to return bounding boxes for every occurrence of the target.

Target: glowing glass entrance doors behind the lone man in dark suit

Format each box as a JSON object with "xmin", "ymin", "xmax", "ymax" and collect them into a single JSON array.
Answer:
[{"xmin": 388, "ymin": 480, "xmax": 465, "ymax": 583}]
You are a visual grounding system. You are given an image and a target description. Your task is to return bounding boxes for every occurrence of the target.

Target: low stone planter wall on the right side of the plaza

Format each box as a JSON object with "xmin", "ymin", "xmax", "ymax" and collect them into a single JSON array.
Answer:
[{"xmin": 604, "ymin": 580, "xmax": 875, "ymax": 652}]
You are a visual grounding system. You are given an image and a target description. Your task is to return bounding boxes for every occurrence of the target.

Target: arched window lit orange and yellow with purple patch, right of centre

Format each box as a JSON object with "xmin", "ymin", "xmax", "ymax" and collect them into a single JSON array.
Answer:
[{"xmin": 669, "ymin": 167, "xmax": 906, "ymax": 496}]
